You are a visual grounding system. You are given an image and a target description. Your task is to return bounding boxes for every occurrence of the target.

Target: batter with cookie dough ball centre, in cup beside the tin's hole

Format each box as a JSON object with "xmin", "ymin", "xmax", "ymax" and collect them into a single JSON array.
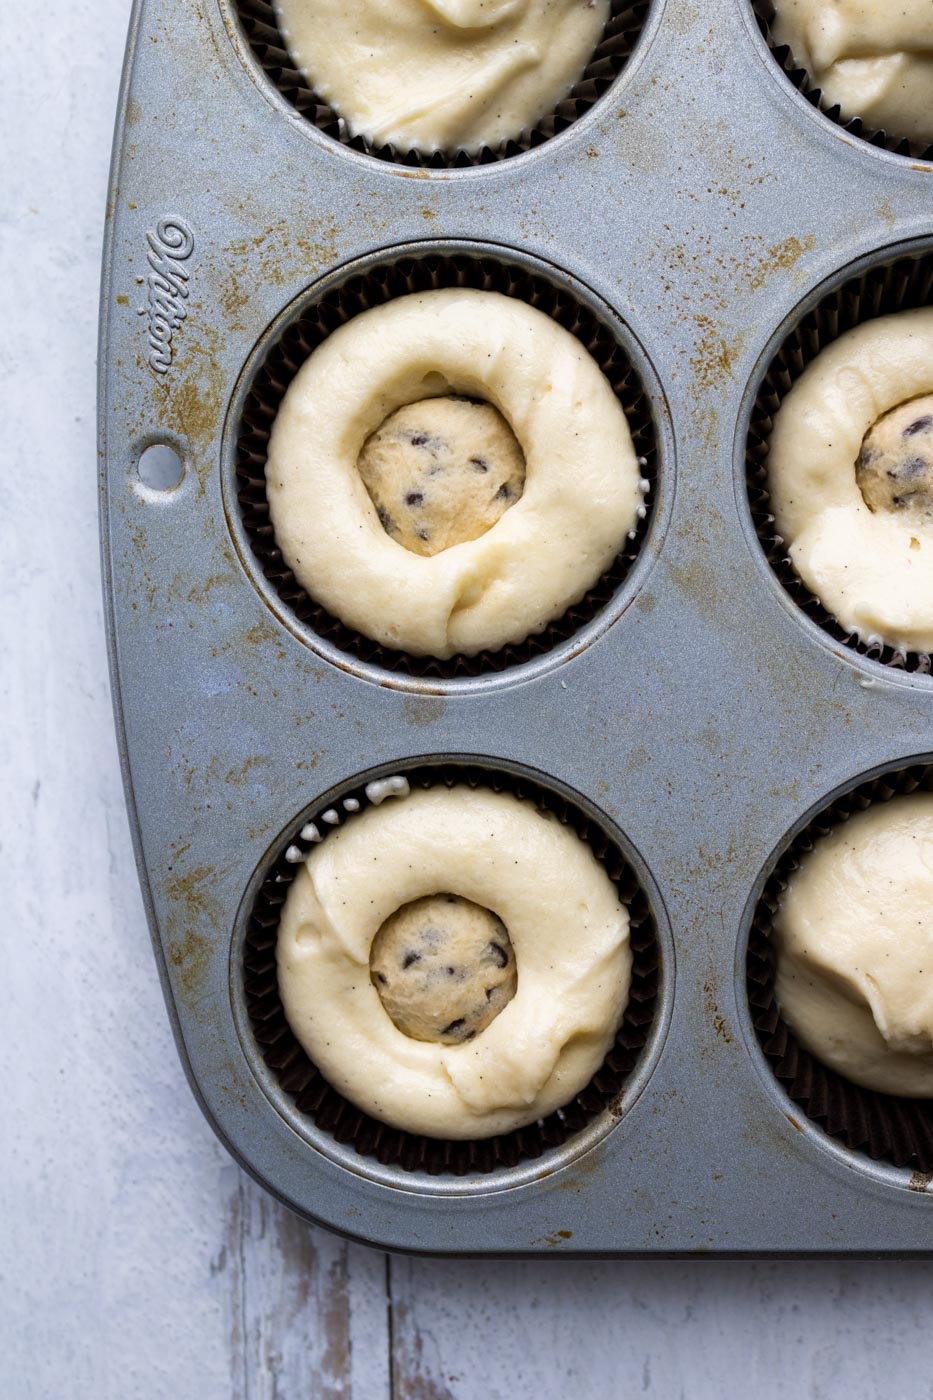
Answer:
[{"xmin": 266, "ymin": 288, "xmax": 644, "ymax": 658}]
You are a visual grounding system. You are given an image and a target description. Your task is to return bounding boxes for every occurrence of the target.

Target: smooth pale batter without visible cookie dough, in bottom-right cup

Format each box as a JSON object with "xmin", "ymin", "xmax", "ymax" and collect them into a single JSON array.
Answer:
[{"xmin": 775, "ymin": 794, "xmax": 933, "ymax": 1099}]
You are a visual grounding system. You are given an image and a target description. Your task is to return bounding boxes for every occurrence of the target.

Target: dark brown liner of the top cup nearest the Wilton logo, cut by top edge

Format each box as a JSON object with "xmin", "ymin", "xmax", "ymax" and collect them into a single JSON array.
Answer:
[{"xmin": 235, "ymin": 0, "xmax": 650, "ymax": 169}]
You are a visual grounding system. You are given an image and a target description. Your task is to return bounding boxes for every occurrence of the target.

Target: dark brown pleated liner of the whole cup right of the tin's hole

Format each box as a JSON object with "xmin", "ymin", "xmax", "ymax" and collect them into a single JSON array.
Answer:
[{"xmin": 235, "ymin": 248, "xmax": 658, "ymax": 680}]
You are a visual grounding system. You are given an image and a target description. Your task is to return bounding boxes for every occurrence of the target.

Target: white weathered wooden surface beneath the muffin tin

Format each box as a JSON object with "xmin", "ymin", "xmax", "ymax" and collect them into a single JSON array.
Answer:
[{"xmin": 0, "ymin": 0, "xmax": 933, "ymax": 1400}]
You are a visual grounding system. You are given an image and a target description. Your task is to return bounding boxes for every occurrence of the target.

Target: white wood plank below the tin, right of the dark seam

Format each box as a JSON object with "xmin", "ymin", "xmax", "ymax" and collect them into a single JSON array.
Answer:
[{"xmin": 392, "ymin": 1259, "xmax": 933, "ymax": 1400}]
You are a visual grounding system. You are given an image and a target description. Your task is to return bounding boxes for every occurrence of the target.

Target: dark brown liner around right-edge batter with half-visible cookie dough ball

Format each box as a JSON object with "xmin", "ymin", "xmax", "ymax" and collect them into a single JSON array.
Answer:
[{"xmin": 745, "ymin": 253, "xmax": 933, "ymax": 675}]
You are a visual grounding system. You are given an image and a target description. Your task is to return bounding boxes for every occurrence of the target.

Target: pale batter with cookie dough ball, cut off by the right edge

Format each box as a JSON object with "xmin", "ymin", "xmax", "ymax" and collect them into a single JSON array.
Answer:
[{"xmin": 768, "ymin": 307, "xmax": 933, "ymax": 652}]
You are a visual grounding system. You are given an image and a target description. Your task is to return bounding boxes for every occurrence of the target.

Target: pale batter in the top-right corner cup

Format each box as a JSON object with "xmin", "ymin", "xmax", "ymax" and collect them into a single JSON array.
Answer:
[{"xmin": 773, "ymin": 0, "xmax": 933, "ymax": 143}]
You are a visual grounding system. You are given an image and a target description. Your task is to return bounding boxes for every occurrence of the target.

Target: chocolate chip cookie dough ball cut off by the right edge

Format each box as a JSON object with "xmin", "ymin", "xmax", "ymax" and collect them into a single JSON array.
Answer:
[{"xmin": 856, "ymin": 393, "xmax": 933, "ymax": 515}]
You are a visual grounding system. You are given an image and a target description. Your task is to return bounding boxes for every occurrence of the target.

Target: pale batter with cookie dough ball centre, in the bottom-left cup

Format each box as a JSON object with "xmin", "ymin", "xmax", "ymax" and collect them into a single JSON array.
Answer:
[{"xmin": 277, "ymin": 785, "xmax": 632, "ymax": 1140}]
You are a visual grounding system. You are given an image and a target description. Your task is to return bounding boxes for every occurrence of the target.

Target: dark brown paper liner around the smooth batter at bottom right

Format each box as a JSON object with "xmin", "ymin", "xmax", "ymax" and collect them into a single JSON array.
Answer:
[{"xmin": 747, "ymin": 764, "xmax": 933, "ymax": 1173}]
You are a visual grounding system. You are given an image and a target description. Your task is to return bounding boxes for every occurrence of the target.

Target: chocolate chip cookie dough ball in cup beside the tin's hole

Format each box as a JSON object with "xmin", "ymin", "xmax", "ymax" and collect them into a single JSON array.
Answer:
[{"xmin": 357, "ymin": 396, "xmax": 525, "ymax": 556}]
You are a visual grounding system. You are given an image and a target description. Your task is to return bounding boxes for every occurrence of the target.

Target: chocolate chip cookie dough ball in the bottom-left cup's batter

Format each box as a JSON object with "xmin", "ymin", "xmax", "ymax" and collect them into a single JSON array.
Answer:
[{"xmin": 370, "ymin": 895, "xmax": 518, "ymax": 1046}]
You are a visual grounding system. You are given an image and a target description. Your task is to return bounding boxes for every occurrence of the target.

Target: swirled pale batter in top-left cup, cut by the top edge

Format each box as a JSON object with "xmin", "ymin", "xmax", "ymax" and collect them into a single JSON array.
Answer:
[{"xmin": 267, "ymin": 0, "xmax": 609, "ymax": 151}]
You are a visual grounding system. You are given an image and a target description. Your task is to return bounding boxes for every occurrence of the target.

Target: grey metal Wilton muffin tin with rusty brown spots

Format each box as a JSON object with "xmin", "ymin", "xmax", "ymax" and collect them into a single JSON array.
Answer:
[{"xmin": 99, "ymin": 0, "xmax": 933, "ymax": 1256}]
